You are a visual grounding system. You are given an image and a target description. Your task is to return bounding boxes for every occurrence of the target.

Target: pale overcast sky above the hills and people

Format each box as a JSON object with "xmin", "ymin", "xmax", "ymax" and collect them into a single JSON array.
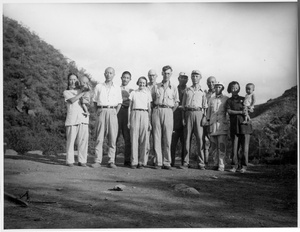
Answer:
[{"xmin": 3, "ymin": 1, "xmax": 297, "ymax": 103}]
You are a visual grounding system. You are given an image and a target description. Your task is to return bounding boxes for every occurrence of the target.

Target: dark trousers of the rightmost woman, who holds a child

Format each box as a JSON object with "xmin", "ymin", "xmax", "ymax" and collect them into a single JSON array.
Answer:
[{"xmin": 231, "ymin": 134, "xmax": 250, "ymax": 169}]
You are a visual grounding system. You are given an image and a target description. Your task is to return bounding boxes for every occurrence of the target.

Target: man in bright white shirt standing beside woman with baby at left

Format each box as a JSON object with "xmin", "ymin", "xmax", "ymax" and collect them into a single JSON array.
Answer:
[{"xmin": 92, "ymin": 67, "xmax": 122, "ymax": 168}]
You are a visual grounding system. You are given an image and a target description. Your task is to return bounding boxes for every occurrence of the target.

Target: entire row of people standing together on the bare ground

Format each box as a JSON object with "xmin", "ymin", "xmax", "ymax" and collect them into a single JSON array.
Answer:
[{"xmin": 64, "ymin": 66, "xmax": 251, "ymax": 171}]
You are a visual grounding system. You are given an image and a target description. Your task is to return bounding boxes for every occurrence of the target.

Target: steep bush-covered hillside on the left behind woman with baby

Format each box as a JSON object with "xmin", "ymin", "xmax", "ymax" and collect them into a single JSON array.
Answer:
[{"xmin": 3, "ymin": 17, "xmax": 90, "ymax": 152}]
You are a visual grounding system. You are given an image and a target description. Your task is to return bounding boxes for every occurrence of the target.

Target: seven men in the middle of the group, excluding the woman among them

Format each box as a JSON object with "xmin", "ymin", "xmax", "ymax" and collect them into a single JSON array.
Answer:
[{"xmin": 92, "ymin": 65, "xmax": 216, "ymax": 170}]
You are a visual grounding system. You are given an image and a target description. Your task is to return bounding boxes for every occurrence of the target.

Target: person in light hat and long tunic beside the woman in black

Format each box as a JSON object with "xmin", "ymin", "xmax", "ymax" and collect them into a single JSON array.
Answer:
[{"xmin": 207, "ymin": 82, "xmax": 229, "ymax": 171}]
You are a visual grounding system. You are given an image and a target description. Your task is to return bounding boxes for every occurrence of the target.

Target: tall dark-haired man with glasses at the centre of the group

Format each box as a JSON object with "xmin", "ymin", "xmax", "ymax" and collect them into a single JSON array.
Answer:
[{"xmin": 152, "ymin": 65, "xmax": 179, "ymax": 170}]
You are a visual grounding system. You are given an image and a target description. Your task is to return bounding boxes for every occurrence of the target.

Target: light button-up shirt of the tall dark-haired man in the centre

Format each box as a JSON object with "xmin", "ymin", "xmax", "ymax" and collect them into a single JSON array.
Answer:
[{"xmin": 152, "ymin": 82, "xmax": 179, "ymax": 107}]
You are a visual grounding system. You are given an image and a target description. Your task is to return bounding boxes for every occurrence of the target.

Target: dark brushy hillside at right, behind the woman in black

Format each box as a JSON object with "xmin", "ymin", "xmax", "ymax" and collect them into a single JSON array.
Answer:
[{"xmin": 250, "ymin": 86, "xmax": 298, "ymax": 163}]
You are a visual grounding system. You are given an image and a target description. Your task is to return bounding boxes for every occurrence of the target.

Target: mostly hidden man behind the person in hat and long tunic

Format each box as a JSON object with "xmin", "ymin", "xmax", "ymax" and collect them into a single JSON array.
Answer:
[{"xmin": 203, "ymin": 76, "xmax": 216, "ymax": 165}]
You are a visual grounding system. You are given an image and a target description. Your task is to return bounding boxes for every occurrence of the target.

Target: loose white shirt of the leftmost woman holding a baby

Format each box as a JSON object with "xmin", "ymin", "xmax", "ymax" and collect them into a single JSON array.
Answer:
[{"xmin": 63, "ymin": 89, "xmax": 89, "ymax": 126}]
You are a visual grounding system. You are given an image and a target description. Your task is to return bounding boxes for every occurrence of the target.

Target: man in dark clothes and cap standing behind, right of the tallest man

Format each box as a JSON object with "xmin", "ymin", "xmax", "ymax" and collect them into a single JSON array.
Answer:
[{"xmin": 171, "ymin": 72, "xmax": 188, "ymax": 167}]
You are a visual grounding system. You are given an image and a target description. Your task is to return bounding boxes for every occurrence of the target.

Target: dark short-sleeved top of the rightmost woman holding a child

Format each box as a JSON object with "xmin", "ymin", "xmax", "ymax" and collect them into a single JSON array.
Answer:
[{"xmin": 226, "ymin": 95, "xmax": 252, "ymax": 136}]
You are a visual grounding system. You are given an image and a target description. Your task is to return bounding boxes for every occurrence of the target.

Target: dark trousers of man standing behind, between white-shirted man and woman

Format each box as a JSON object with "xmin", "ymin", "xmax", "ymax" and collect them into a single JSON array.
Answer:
[{"xmin": 117, "ymin": 107, "xmax": 131, "ymax": 164}]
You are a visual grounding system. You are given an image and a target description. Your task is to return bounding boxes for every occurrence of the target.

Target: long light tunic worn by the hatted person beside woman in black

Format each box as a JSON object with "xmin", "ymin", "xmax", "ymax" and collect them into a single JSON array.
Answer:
[{"xmin": 207, "ymin": 94, "xmax": 229, "ymax": 136}]
